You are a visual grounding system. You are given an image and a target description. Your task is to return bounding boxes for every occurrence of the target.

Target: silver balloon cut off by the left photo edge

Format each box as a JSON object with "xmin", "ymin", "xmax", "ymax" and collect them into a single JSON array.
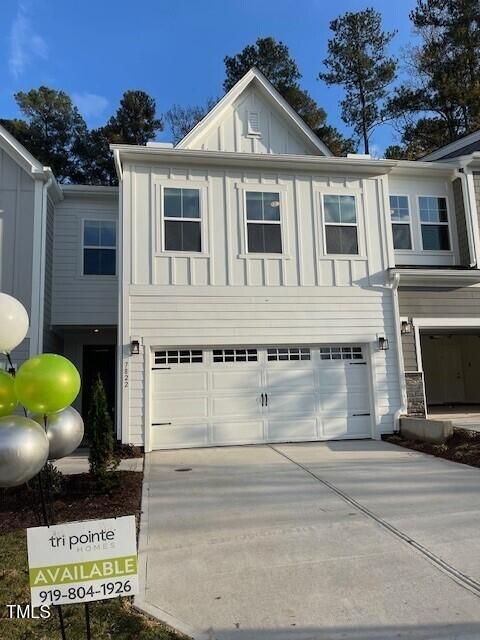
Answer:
[{"xmin": 0, "ymin": 416, "xmax": 49, "ymax": 487}]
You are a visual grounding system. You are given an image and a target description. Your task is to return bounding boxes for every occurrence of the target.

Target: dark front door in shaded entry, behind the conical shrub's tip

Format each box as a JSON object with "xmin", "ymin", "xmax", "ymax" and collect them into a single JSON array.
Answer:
[{"xmin": 82, "ymin": 344, "xmax": 116, "ymax": 424}]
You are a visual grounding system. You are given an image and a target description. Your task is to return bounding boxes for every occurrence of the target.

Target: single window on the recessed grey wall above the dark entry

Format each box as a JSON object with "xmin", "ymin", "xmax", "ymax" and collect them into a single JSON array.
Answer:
[{"xmin": 83, "ymin": 220, "xmax": 117, "ymax": 276}]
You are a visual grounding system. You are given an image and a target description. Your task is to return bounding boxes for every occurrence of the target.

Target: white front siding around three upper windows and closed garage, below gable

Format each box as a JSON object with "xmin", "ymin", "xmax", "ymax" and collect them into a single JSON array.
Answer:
[{"xmin": 122, "ymin": 164, "xmax": 400, "ymax": 444}]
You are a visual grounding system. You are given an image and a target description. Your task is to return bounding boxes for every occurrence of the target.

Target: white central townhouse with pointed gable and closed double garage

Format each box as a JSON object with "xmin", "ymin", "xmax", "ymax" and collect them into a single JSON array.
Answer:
[{"xmin": 112, "ymin": 70, "xmax": 408, "ymax": 450}]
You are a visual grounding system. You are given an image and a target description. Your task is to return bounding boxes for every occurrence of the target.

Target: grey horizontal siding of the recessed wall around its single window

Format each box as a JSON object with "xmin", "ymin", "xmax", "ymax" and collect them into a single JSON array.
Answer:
[{"xmin": 51, "ymin": 191, "xmax": 118, "ymax": 326}]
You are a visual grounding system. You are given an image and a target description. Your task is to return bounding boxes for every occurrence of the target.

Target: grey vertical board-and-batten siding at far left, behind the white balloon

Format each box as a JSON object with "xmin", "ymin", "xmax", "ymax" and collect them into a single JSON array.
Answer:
[{"xmin": 0, "ymin": 148, "xmax": 35, "ymax": 364}]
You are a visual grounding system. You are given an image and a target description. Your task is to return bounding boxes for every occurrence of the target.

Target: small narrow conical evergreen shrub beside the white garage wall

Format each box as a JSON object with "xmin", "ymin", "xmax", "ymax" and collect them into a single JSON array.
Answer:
[{"xmin": 88, "ymin": 376, "xmax": 120, "ymax": 491}]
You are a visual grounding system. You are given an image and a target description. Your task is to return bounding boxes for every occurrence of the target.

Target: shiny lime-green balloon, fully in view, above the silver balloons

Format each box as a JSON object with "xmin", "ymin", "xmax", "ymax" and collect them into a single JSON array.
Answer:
[{"xmin": 15, "ymin": 353, "xmax": 80, "ymax": 414}]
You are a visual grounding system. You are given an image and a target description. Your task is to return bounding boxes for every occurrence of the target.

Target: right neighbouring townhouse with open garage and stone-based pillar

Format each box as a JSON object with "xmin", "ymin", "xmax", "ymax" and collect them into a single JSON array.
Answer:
[{"xmin": 389, "ymin": 132, "xmax": 480, "ymax": 424}]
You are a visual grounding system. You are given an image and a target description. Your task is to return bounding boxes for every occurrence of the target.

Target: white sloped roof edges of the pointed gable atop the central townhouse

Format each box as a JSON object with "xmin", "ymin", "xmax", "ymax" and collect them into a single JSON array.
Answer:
[{"xmin": 175, "ymin": 67, "xmax": 333, "ymax": 156}]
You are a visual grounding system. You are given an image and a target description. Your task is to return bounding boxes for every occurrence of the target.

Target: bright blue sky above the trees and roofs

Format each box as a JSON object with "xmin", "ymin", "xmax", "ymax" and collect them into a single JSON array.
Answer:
[{"xmin": 0, "ymin": 0, "xmax": 416, "ymax": 152}]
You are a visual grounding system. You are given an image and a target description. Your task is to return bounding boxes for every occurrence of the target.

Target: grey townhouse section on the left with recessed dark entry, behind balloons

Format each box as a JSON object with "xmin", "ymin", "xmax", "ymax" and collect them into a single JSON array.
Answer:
[{"xmin": 0, "ymin": 126, "xmax": 118, "ymax": 414}]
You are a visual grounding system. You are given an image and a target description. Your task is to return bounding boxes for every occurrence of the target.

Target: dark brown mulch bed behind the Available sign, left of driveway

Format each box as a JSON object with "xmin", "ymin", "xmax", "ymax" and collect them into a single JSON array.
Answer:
[{"xmin": 0, "ymin": 471, "xmax": 143, "ymax": 533}]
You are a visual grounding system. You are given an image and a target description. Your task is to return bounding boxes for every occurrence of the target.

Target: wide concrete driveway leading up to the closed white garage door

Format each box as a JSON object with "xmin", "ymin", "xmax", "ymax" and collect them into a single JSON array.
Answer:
[{"xmin": 136, "ymin": 441, "xmax": 480, "ymax": 640}]
